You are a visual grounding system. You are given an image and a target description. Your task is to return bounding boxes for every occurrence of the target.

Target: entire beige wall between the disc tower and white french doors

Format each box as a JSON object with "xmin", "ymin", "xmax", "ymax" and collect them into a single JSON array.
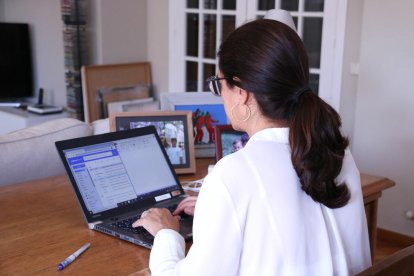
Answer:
[{"xmin": 88, "ymin": 0, "xmax": 168, "ymax": 98}]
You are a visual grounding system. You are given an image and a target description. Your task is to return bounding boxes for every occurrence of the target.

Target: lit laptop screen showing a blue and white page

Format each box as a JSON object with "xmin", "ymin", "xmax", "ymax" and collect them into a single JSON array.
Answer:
[{"xmin": 64, "ymin": 134, "xmax": 178, "ymax": 214}]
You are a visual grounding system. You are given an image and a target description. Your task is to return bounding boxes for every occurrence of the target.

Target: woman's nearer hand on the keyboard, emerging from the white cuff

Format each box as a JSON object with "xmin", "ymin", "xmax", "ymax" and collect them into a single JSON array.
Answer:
[{"xmin": 132, "ymin": 208, "xmax": 180, "ymax": 236}]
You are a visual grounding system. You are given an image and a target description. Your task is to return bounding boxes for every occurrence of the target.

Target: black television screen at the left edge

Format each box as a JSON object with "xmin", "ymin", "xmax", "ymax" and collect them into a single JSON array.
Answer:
[{"xmin": 0, "ymin": 23, "xmax": 34, "ymax": 100}]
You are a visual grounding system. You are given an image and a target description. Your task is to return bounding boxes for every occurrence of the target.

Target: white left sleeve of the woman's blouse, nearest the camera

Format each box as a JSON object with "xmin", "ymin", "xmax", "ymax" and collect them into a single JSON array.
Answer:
[{"xmin": 150, "ymin": 171, "xmax": 242, "ymax": 276}]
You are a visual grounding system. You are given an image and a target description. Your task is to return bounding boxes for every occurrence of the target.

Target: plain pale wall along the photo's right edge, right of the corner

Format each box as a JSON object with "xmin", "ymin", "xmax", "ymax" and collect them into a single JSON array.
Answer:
[{"xmin": 353, "ymin": 0, "xmax": 414, "ymax": 236}]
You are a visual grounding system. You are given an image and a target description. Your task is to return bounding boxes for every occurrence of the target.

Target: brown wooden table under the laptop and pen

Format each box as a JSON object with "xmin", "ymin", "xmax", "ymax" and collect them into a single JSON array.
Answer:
[{"xmin": 0, "ymin": 159, "xmax": 395, "ymax": 275}]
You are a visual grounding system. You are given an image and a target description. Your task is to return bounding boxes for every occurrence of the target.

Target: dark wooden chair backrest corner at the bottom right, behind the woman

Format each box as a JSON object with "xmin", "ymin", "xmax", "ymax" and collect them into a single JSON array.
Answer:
[{"xmin": 357, "ymin": 245, "xmax": 414, "ymax": 276}]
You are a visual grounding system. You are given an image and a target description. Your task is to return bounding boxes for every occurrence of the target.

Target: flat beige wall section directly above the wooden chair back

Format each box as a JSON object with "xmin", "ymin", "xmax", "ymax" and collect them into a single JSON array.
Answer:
[{"xmin": 88, "ymin": 0, "xmax": 148, "ymax": 64}]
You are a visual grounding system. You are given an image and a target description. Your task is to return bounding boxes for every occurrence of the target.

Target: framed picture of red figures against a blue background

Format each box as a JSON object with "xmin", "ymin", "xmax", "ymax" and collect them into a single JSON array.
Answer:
[{"xmin": 161, "ymin": 92, "xmax": 229, "ymax": 157}]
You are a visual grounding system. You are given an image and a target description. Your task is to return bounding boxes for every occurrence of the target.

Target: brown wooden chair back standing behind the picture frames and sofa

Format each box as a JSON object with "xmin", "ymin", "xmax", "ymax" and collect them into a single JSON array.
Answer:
[{"xmin": 81, "ymin": 62, "xmax": 151, "ymax": 123}]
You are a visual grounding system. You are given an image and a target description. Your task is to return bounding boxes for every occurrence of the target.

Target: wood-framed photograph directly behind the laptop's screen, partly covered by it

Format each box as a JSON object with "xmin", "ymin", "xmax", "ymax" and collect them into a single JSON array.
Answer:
[{"xmin": 109, "ymin": 111, "xmax": 196, "ymax": 174}]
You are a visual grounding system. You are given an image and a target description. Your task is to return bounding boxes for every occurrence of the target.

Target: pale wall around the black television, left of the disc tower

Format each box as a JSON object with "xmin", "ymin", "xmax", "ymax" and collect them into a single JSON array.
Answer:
[{"xmin": 0, "ymin": 0, "xmax": 66, "ymax": 105}]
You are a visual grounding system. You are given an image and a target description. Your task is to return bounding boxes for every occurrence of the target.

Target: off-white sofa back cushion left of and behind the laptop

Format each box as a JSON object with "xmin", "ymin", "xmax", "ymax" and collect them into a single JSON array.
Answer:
[{"xmin": 0, "ymin": 118, "xmax": 92, "ymax": 185}]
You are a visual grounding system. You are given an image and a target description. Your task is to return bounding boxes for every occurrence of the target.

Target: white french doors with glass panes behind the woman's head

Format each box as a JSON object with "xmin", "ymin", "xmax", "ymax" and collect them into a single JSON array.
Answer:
[{"xmin": 169, "ymin": 0, "xmax": 346, "ymax": 108}]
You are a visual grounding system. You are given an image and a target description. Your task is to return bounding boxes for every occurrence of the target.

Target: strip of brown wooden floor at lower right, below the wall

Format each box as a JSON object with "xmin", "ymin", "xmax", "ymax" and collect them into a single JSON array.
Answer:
[{"xmin": 375, "ymin": 229, "xmax": 414, "ymax": 262}]
